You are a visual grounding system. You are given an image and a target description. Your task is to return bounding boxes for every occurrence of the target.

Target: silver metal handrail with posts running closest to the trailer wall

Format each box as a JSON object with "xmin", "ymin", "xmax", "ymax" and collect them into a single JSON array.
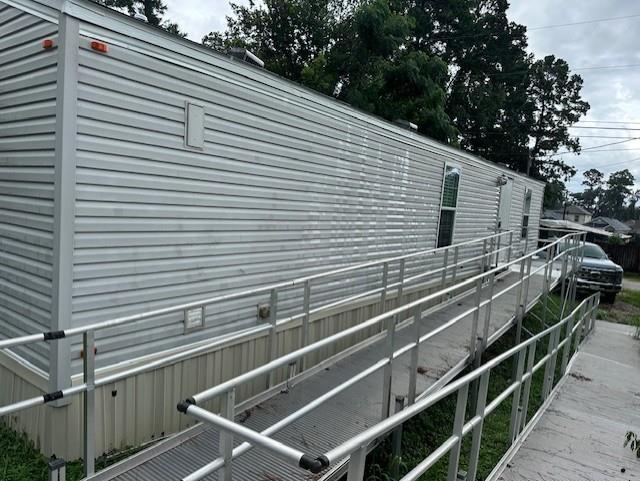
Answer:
[{"xmin": 0, "ymin": 231, "xmax": 513, "ymax": 476}]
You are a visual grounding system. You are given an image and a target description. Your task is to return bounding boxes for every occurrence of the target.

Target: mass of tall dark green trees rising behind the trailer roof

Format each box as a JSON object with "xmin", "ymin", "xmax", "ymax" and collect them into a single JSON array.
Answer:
[{"xmin": 203, "ymin": 0, "xmax": 589, "ymax": 186}]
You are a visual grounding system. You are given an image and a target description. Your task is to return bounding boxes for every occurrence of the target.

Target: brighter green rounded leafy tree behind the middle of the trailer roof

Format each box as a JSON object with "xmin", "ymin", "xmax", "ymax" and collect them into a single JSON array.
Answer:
[{"xmin": 316, "ymin": 0, "xmax": 457, "ymax": 143}]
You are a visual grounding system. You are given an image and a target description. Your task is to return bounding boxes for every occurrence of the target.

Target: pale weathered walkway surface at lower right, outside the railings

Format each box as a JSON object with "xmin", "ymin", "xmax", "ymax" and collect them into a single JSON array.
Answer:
[{"xmin": 493, "ymin": 321, "xmax": 640, "ymax": 481}]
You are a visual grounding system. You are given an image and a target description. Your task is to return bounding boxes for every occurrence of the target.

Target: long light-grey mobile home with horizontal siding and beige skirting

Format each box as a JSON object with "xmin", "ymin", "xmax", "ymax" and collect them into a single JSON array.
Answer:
[{"xmin": 0, "ymin": 0, "xmax": 544, "ymax": 457}]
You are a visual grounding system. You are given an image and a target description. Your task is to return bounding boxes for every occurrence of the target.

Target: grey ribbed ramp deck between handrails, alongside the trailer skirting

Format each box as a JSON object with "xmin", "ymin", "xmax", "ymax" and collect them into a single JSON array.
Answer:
[{"xmin": 92, "ymin": 262, "xmax": 560, "ymax": 481}]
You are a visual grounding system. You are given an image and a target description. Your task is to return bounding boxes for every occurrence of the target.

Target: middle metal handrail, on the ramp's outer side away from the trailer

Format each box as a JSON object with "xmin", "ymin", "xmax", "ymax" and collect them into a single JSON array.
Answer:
[{"xmin": 179, "ymin": 233, "xmax": 583, "ymax": 481}]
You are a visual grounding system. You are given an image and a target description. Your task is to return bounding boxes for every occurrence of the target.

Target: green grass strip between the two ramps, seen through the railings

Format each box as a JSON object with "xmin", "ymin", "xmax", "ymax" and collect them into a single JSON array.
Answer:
[{"xmin": 365, "ymin": 296, "xmax": 572, "ymax": 481}]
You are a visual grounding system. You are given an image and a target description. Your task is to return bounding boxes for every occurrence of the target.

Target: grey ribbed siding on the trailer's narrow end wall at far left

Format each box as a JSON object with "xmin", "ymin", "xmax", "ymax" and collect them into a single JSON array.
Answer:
[{"xmin": 0, "ymin": 2, "xmax": 57, "ymax": 369}]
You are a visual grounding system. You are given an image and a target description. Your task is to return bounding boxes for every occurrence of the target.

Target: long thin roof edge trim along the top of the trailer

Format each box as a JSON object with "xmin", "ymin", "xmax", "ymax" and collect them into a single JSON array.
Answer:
[{"xmin": 7, "ymin": 0, "xmax": 546, "ymax": 186}]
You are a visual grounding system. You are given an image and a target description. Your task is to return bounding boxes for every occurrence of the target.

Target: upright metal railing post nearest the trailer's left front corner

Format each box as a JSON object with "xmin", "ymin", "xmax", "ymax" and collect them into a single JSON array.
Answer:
[{"xmin": 82, "ymin": 331, "xmax": 96, "ymax": 477}]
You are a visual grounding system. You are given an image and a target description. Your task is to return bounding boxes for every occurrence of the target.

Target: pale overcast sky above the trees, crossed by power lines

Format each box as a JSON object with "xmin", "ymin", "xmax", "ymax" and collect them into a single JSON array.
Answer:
[{"xmin": 166, "ymin": 0, "xmax": 640, "ymax": 191}]
